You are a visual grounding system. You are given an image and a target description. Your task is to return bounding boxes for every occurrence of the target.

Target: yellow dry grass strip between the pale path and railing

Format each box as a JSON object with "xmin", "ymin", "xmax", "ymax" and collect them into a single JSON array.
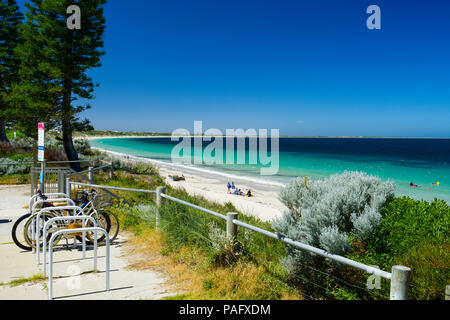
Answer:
[{"xmin": 120, "ymin": 229, "xmax": 302, "ymax": 300}]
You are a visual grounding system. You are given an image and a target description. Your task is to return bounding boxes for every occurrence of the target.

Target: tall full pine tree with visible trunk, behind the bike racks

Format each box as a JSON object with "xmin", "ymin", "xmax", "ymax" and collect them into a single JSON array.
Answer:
[{"xmin": 13, "ymin": 0, "xmax": 106, "ymax": 169}]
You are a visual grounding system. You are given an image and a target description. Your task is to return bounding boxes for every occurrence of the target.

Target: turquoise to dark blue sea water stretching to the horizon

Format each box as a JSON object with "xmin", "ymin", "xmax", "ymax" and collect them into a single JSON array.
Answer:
[{"xmin": 91, "ymin": 138, "xmax": 450, "ymax": 202}]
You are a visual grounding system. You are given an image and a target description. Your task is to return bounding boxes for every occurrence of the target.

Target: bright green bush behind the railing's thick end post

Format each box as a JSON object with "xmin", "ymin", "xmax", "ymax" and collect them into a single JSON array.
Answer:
[{"xmin": 352, "ymin": 197, "xmax": 450, "ymax": 300}]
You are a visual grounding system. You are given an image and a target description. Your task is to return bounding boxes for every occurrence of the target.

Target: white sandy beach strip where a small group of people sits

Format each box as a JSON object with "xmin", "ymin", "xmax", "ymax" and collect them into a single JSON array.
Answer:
[{"xmin": 92, "ymin": 147, "xmax": 287, "ymax": 221}]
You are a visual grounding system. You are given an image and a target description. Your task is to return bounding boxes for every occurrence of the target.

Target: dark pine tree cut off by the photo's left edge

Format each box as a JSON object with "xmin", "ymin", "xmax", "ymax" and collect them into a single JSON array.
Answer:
[{"xmin": 0, "ymin": 0, "xmax": 23, "ymax": 142}]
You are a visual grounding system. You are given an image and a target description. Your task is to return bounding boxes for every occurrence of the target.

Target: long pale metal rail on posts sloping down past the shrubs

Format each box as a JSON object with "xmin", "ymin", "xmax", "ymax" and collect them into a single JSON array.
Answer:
[{"xmin": 68, "ymin": 181, "xmax": 411, "ymax": 300}]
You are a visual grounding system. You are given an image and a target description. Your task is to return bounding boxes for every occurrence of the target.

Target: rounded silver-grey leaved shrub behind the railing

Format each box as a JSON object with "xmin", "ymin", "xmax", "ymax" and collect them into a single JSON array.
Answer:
[{"xmin": 273, "ymin": 172, "xmax": 395, "ymax": 268}]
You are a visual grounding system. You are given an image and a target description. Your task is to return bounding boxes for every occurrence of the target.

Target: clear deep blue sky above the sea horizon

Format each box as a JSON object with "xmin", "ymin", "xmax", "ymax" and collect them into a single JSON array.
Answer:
[{"xmin": 15, "ymin": 0, "xmax": 450, "ymax": 137}]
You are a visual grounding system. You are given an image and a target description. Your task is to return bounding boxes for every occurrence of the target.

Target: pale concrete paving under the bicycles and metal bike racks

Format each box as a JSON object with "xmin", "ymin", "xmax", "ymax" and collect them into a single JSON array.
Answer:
[{"xmin": 0, "ymin": 186, "xmax": 177, "ymax": 300}]
